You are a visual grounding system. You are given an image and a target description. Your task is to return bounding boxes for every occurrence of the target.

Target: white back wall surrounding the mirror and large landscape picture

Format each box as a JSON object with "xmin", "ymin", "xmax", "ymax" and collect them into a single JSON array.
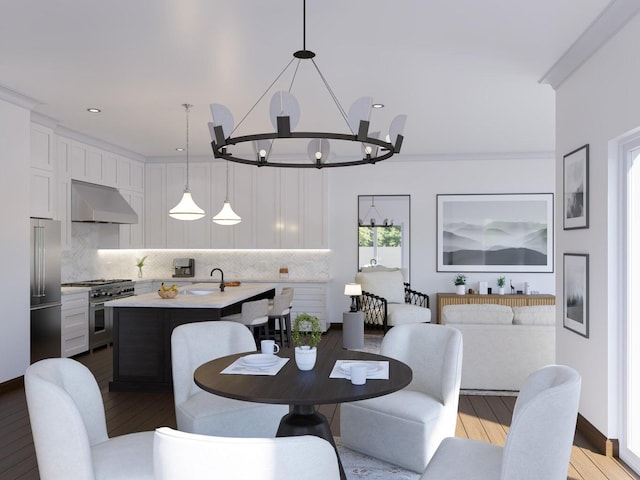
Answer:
[{"xmin": 329, "ymin": 155, "xmax": 555, "ymax": 323}]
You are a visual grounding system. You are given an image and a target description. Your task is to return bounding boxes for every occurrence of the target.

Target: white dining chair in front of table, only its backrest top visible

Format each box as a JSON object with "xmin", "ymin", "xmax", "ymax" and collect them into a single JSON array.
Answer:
[{"xmin": 153, "ymin": 427, "xmax": 340, "ymax": 480}]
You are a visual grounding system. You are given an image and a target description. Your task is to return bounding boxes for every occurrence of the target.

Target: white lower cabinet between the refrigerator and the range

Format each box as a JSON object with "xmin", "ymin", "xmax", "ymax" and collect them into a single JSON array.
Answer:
[{"xmin": 61, "ymin": 292, "xmax": 89, "ymax": 357}]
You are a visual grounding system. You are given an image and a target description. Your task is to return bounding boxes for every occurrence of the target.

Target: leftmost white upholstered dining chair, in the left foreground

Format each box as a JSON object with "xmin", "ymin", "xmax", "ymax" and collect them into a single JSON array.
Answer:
[{"xmin": 24, "ymin": 358, "xmax": 154, "ymax": 480}]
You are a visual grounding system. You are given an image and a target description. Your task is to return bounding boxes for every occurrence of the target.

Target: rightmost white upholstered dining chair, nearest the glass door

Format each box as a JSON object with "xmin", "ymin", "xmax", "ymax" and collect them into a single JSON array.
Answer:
[{"xmin": 420, "ymin": 365, "xmax": 581, "ymax": 480}]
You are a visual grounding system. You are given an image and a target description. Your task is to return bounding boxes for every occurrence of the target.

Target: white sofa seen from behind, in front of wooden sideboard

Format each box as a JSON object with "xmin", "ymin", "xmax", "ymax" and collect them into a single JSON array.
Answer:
[{"xmin": 441, "ymin": 304, "xmax": 556, "ymax": 391}]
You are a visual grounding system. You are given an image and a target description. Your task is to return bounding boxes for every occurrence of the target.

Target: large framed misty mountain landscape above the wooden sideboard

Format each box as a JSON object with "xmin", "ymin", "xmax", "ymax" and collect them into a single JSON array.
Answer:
[{"xmin": 437, "ymin": 193, "xmax": 554, "ymax": 273}]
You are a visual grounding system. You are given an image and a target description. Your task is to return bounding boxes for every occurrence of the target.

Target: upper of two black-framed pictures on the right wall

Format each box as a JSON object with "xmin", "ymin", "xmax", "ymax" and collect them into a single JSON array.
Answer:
[{"xmin": 562, "ymin": 144, "xmax": 589, "ymax": 230}]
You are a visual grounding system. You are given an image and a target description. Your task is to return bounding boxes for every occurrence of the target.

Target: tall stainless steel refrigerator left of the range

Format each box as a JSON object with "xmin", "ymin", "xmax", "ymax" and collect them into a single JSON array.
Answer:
[{"xmin": 30, "ymin": 218, "xmax": 62, "ymax": 363}]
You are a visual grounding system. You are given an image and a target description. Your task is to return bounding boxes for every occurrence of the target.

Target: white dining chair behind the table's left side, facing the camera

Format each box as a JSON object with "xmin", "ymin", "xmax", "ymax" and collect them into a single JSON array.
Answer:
[{"xmin": 171, "ymin": 320, "xmax": 289, "ymax": 437}]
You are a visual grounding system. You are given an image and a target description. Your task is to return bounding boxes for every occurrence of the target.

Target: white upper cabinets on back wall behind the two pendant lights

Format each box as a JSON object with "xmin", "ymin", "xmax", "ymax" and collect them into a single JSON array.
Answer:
[{"xmin": 145, "ymin": 161, "xmax": 327, "ymax": 248}]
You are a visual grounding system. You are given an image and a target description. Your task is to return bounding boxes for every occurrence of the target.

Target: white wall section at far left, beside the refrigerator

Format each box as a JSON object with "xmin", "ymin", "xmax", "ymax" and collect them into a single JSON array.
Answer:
[{"xmin": 0, "ymin": 99, "xmax": 31, "ymax": 383}]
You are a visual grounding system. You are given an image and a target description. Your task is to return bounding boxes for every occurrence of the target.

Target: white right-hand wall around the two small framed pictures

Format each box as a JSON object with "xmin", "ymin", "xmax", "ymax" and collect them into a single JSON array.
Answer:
[{"xmin": 556, "ymin": 12, "xmax": 640, "ymax": 438}]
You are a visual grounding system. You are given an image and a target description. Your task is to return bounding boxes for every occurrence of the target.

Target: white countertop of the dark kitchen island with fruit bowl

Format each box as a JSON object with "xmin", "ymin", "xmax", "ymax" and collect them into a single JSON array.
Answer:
[{"xmin": 104, "ymin": 283, "xmax": 277, "ymax": 308}]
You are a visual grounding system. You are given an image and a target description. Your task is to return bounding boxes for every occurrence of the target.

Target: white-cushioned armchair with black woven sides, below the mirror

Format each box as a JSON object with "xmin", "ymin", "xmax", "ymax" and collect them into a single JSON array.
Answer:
[{"xmin": 355, "ymin": 268, "xmax": 431, "ymax": 332}]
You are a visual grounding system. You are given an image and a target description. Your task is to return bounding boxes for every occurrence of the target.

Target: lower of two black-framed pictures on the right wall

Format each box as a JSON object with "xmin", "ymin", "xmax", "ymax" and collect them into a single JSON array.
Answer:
[{"xmin": 562, "ymin": 253, "xmax": 589, "ymax": 338}]
